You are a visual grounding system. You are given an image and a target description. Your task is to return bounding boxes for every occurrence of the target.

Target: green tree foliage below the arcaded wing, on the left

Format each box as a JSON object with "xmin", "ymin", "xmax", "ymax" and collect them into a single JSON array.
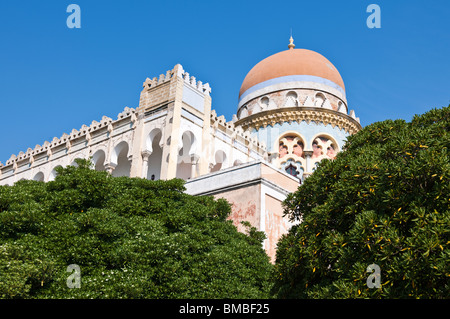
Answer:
[{"xmin": 0, "ymin": 160, "xmax": 273, "ymax": 298}]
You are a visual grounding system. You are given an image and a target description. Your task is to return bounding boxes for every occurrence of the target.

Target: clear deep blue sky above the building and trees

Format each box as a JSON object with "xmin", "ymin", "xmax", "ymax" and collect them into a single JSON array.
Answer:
[{"xmin": 0, "ymin": 0, "xmax": 450, "ymax": 163}]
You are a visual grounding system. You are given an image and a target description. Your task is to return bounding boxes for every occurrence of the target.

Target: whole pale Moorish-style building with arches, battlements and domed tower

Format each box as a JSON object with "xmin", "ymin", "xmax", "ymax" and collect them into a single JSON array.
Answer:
[{"xmin": 0, "ymin": 38, "xmax": 361, "ymax": 260}]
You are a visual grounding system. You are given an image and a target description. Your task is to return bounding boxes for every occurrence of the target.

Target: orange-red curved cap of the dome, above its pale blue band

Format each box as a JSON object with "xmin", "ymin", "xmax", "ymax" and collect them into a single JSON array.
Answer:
[{"xmin": 239, "ymin": 48, "xmax": 345, "ymax": 97}]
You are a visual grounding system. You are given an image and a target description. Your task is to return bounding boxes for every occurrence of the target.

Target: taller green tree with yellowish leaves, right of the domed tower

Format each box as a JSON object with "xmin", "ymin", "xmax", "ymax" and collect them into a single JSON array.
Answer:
[{"xmin": 274, "ymin": 106, "xmax": 450, "ymax": 298}]
